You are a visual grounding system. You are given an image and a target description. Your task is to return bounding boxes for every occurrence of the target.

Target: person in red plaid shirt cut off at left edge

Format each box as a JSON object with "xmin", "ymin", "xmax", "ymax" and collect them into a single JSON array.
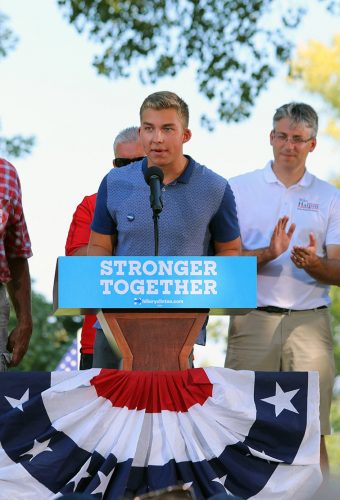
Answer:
[{"xmin": 0, "ymin": 158, "xmax": 32, "ymax": 371}]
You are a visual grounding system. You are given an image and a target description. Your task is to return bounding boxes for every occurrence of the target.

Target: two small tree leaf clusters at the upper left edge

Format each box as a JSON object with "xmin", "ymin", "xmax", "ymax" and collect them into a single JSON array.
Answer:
[{"xmin": 0, "ymin": 12, "xmax": 35, "ymax": 158}]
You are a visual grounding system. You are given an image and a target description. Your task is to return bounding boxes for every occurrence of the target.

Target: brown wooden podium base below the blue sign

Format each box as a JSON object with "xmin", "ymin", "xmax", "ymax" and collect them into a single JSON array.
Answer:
[{"xmin": 97, "ymin": 309, "xmax": 209, "ymax": 371}]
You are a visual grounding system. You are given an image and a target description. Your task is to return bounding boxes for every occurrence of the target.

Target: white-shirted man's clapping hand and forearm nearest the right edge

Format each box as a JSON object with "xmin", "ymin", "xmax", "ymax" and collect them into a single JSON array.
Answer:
[{"xmin": 291, "ymin": 233, "xmax": 340, "ymax": 286}]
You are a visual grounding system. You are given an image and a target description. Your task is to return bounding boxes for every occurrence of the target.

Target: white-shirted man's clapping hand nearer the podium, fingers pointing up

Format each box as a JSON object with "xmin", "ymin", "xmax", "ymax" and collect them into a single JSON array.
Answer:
[{"xmin": 242, "ymin": 216, "xmax": 295, "ymax": 268}]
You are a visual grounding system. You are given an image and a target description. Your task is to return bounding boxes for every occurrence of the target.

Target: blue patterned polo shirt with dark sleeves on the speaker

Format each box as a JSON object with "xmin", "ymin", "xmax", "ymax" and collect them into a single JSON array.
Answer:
[{"xmin": 91, "ymin": 157, "xmax": 240, "ymax": 256}]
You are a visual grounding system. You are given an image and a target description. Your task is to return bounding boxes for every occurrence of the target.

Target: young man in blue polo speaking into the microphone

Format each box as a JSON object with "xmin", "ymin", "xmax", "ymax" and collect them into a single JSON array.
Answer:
[{"xmin": 88, "ymin": 92, "xmax": 240, "ymax": 356}]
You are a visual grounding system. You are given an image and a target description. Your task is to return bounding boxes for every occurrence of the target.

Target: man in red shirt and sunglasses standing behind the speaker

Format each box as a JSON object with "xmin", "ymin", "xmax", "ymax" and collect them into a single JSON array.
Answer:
[{"xmin": 65, "ymin": 127, "xmax": 145, "ymax": 370}]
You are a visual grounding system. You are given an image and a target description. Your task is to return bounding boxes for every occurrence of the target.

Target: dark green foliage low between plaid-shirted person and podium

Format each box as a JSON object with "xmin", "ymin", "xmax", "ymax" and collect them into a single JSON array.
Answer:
[{"xmin": 9, "ymin": 291, "xmax": 81, "ymax": 371}]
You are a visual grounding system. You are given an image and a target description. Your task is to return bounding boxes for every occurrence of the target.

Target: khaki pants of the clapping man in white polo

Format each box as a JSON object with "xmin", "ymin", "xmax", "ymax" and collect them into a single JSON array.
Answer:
[{"xmin": 225, "ymin": 309, "xmax": 335, "ymax": 435}]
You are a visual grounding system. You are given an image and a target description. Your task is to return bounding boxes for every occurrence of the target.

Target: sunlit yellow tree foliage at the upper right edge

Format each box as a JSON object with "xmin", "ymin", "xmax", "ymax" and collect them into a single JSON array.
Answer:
[{"xmin": 290, "ymin": 34, "xmax": 340, "ymax": 140}]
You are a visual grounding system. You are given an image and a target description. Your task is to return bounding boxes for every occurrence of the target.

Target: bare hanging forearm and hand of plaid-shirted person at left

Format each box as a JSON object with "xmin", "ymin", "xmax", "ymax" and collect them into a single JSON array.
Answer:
[{"xmin": 7, "ymin": 258, "xmax": 33, "ymax": 367}]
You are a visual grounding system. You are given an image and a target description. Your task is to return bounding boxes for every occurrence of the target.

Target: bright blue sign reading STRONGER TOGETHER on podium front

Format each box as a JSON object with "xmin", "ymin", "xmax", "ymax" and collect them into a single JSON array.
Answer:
[{"xmin": 55, "ymin": 256, "xmax": 256, "ymax": 314}]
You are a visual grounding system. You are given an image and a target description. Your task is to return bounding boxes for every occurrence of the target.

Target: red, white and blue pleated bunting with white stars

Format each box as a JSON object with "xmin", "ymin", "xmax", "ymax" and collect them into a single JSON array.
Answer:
[{"xmin": 0, "ymin": 368, "xmax": 321, "ymax": 500}]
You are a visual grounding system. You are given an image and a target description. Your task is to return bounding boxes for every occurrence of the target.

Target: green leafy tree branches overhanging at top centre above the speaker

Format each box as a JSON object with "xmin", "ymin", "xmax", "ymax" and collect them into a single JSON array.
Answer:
[{"xmin": 58, "ymin": 0, "xmax": 340, "ymax": 128}]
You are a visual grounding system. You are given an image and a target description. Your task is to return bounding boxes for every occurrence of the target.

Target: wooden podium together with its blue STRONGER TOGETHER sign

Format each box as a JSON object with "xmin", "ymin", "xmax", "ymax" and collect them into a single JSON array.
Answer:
[{"xmin": 53, "ymin": 256, "xmax": 256, "ymax": 371}]
